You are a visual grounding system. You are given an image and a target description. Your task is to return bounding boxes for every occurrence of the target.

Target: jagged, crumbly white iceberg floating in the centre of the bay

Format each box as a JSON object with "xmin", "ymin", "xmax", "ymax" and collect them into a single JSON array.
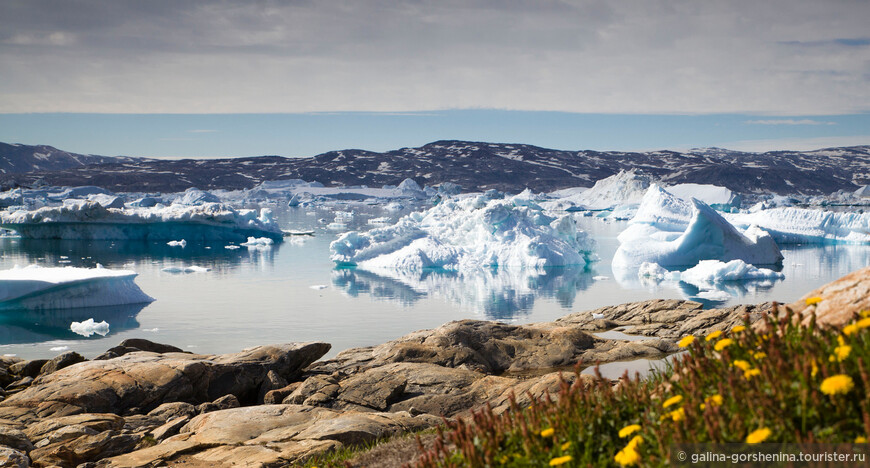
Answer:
[{"xmin": 330, "ymin": 197, "xmax": 594, "ymax": 271}]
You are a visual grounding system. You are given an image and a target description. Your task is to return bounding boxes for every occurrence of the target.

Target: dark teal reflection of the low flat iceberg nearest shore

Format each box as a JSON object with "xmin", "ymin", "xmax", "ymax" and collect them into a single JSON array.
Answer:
[{"xmin": 0, "ymin": 303, "xmax": 149, "ymax": 345}]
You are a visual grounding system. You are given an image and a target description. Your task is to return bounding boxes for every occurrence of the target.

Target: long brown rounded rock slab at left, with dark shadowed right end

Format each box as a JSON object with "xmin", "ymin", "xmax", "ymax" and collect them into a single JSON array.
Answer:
[{"xmin": 0, "ymin": 343, "xmax": 329, "ymax": 422}]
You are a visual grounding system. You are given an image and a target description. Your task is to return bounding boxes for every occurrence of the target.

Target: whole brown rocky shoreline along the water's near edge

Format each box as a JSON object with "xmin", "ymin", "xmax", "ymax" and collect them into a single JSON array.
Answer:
[{"xmin": 0, "ymin": 268, "xmax": 870, "ymax": 467}]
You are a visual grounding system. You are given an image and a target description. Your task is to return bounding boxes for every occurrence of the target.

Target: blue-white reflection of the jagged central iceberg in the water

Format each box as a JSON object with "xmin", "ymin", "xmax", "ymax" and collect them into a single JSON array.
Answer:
[{"xmin": 332, "ymin": 267, "xmax": 593, "ymax": 320}]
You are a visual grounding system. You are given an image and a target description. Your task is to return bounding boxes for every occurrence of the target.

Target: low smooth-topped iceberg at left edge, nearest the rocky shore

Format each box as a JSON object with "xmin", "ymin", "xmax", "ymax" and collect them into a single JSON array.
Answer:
[{"xmin": 0, "ymin": 265, "xmax": 154, "ymax": 310}]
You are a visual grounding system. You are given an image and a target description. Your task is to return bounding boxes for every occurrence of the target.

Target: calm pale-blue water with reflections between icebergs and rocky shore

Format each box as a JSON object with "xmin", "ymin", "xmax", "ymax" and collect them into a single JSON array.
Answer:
[{"xmin": 0, "ymin": 204, "xmax": 870, "ymax": 358}]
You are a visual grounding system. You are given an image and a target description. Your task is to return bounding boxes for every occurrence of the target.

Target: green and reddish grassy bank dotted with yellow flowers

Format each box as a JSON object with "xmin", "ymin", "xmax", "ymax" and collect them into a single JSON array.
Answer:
[{"xmin": 417, "ymin": 306, "xmax": 870, "ymax": 467}]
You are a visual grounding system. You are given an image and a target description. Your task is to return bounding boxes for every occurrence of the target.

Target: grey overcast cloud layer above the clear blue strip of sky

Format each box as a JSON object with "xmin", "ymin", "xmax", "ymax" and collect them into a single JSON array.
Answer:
[{"xmin": 0, "ymin": 0, "xmax": 870, "ymax": 115}]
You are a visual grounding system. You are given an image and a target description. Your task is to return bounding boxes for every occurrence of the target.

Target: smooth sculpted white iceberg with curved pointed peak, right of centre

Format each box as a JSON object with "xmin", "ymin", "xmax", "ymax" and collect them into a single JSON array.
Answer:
[{"xmin": 613, "ymin": 196, "xmax": 783, "ymax": 269}]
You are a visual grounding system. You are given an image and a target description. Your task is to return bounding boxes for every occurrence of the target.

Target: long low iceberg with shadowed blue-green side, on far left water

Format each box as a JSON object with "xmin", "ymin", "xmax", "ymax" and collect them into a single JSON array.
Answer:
[{"xmin": 0, "ymin": 201, "xmax": 283, "ymax": 243}]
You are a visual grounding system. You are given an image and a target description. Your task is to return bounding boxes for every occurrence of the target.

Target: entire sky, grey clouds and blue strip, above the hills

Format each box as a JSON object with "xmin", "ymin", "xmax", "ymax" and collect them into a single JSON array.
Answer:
[{"xmin": 0, "ymin": 0, "xmax": 870, "ymax": 157}]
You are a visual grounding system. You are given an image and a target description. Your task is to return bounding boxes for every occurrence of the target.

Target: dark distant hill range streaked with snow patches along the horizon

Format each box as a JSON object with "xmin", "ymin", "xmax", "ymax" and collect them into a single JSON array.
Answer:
[{"xmin": 0, "ymin": 141, "xmax": 870, "ymax": 195}]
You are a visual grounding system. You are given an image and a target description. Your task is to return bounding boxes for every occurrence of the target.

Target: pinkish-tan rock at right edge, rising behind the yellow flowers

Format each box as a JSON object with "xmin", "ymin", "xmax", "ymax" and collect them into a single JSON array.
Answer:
[{"xmin": 778, "ymin": 267, "xmax": 870, "ymax": 328}]
